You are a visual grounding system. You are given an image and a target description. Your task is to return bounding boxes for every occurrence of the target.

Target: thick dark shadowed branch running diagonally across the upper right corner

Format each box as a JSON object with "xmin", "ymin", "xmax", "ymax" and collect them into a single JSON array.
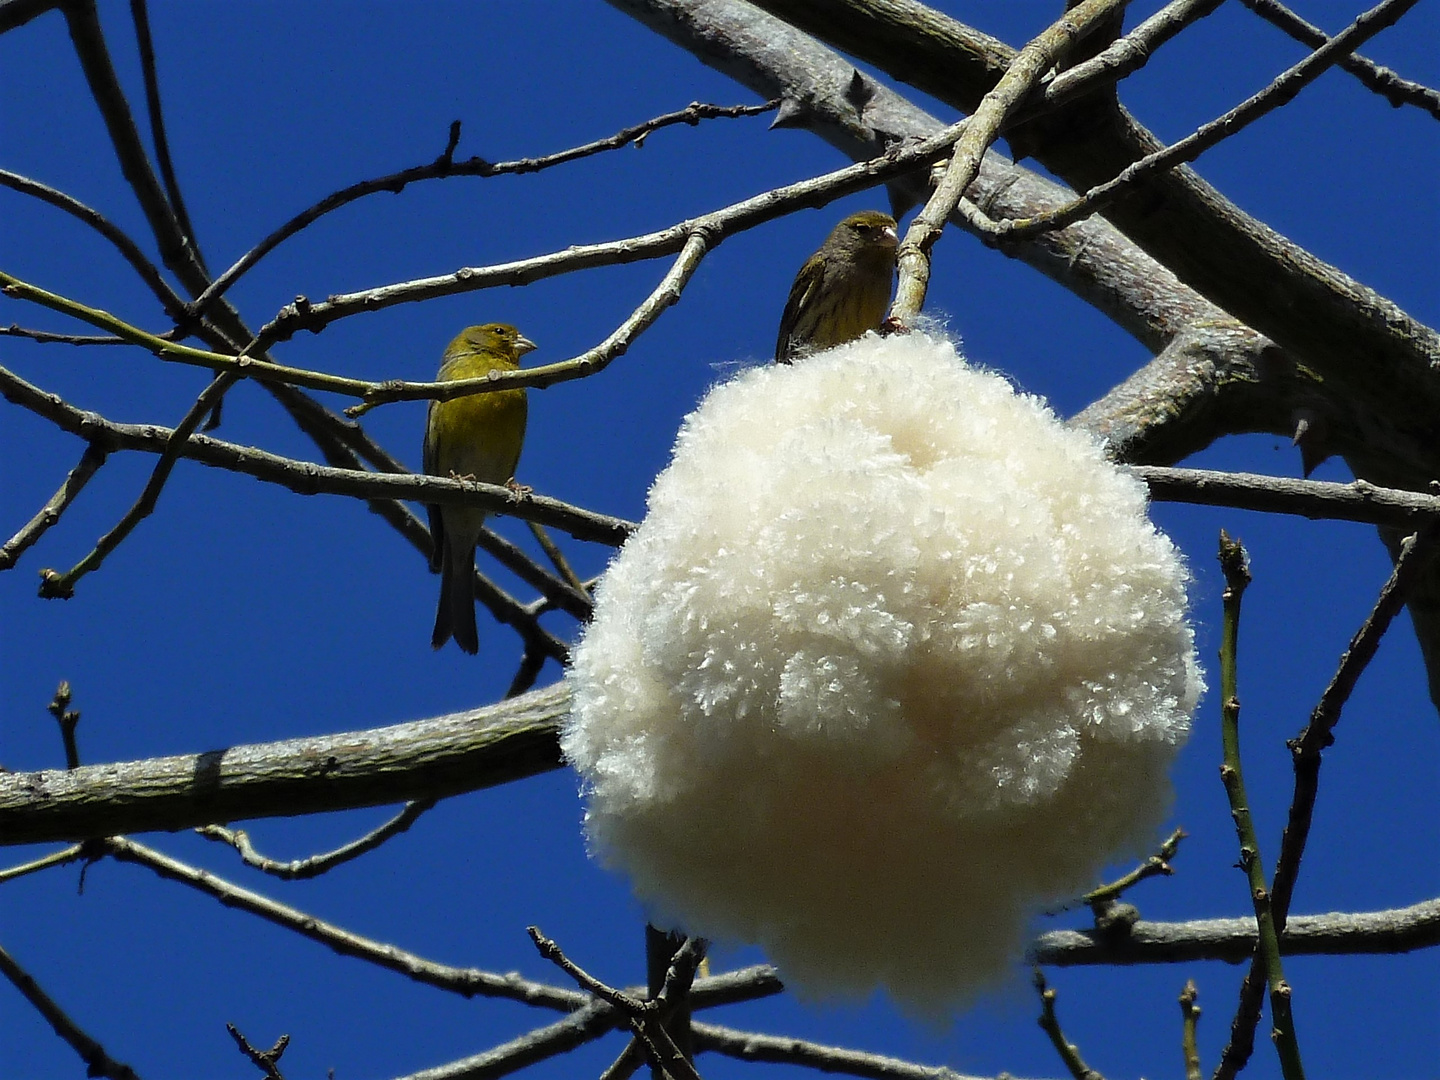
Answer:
[{"xmin": 759, "ymin": 0, "xmax": 1440, "ymax": 408}]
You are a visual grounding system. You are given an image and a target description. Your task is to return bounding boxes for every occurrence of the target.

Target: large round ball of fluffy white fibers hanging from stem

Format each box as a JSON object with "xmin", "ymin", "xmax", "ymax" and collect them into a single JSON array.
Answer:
[{"xmin": 562, "ymin": 334, "xmax": 1202, "ymax": 1015}]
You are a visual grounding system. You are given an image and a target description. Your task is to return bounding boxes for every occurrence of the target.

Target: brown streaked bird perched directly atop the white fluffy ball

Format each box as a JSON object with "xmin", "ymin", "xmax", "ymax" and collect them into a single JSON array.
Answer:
[{"xmin": 775, "ymin": 210, "xmax": 900, "ymax": 364}]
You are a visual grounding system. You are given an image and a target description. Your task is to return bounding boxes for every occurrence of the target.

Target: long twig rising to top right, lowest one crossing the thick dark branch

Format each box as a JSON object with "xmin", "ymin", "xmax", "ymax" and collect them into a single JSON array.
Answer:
[{"xmin": 986, "ymin": 0, "xmax": 1420, "ymax": 238}]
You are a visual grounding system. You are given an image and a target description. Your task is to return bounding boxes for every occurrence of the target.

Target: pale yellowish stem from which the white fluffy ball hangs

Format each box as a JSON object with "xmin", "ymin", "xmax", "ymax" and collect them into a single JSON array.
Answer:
[{"xmin": 890, "ymin": 0, "xmax": 1128, "ymax": 327}]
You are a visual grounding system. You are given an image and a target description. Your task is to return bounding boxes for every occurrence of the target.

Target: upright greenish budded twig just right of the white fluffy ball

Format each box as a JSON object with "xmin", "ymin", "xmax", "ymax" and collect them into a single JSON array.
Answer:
[{"xmin": 1217, "ymin": 531, "xmax": 1305, "ymax": 1080}]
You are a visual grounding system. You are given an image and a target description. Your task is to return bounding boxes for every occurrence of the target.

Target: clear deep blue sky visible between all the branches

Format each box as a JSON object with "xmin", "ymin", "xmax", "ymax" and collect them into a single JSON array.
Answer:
[{"xmin": 0, "ymin": 0, "xmax": 1440, "ymax": 1080}]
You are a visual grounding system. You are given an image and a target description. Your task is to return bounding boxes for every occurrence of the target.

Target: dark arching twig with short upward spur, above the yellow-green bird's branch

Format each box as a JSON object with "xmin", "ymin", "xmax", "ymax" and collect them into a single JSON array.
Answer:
[{"xmin": 190, "ymin": 101, "xmax": 779, "ymax": 312}]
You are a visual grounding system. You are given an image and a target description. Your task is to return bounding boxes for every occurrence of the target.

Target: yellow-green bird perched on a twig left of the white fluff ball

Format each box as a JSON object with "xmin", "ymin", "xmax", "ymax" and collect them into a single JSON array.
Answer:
[{"xmin": 425, "ymin": 323, "xmax": 536, "ymax": 654}]
